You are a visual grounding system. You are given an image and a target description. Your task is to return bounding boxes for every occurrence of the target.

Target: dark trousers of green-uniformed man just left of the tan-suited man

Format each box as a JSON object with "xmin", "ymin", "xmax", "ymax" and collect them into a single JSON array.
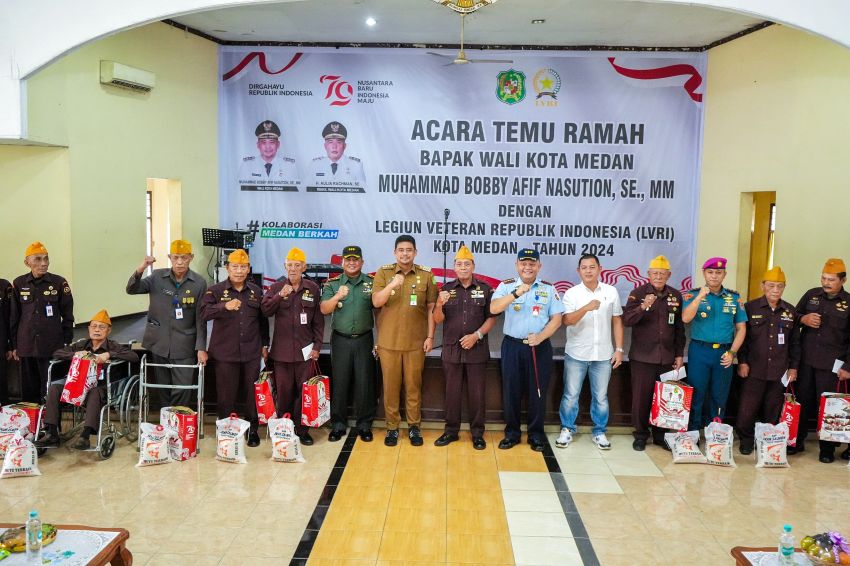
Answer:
[{"xmin": 331, "ymin": 332, "xmax": 378, "ymax": 430}]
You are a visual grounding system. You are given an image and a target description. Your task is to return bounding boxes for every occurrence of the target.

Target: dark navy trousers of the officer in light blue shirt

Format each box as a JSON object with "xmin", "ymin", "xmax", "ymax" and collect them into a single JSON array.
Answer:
[{"xmin": 502, "ymin": 336, "xmax": 552, "ymax": 442}]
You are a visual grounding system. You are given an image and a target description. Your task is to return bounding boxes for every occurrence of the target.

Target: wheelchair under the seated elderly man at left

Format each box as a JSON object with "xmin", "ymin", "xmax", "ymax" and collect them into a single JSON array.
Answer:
[{"xmin": 35, "ymin": 350, "xmax": 141, "ymax": 460}]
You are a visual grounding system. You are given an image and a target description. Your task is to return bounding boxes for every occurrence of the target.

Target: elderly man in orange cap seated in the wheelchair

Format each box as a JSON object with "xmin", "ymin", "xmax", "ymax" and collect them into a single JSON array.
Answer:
[{"xmin": 36, "ymin": 310, "xmax": 139, "ymax": 450}]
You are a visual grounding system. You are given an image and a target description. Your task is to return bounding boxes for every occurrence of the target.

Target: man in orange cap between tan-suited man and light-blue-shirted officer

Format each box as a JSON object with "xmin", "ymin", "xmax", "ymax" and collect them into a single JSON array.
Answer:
[{"xmin": 434, "ymin": 246, "xmax": 496, "ymax": 450}]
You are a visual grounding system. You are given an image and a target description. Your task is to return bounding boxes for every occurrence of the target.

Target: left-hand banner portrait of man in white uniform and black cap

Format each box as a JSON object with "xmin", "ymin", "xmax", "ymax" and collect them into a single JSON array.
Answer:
[{"xmin": 238, "ymin": 120, "xmax": 301, "ymax": 191}]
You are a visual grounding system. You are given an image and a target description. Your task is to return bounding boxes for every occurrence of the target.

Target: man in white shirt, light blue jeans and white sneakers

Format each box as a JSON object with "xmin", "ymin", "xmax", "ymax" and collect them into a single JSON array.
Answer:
[{"xmin": 555, "ymin": 254, "xmax": 623, "ymax": 450}]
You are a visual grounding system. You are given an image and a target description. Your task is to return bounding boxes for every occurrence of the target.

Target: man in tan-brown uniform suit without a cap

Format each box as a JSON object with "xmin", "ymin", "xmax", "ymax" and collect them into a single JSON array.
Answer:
[{"xmin": 372, "ymin": 234, "xmax": 437, "ymax": 446}]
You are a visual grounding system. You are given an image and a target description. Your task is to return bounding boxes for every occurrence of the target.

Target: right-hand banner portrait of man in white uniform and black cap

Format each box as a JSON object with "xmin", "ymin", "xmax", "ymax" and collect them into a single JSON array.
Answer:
[{"xmin": 307, "ymin": 122, "xmax": 366, "ymax": 193}]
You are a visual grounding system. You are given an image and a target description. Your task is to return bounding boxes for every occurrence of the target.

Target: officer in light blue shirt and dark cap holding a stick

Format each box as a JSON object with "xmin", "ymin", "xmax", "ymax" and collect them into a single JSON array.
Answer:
[{"xmin": 490, "ymin": 248, "xmax": 565, "ymax": 452}]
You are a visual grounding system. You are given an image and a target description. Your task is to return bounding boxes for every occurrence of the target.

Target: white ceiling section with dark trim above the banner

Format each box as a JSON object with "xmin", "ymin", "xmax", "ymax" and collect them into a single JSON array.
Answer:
[{"xmin": 169, "ymin": 0, "xmax": 762, "ymax": 47}]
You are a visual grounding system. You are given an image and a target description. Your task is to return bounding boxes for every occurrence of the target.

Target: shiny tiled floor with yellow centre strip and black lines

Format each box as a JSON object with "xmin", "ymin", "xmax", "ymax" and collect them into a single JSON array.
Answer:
[{"xmin": 0, "ymin": 424, "xmax": 850, "ymax": 566}]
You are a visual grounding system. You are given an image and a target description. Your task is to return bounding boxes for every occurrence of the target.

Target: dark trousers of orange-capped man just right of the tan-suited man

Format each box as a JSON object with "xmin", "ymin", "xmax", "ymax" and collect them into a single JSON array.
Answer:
[{"xmin": 443, "ymin": 362, "xmax": 484, "ymax": 437}]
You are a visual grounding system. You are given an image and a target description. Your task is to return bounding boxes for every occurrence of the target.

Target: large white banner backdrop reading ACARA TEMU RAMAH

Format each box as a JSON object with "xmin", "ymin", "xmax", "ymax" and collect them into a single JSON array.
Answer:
[{"xmin": 219, "ymin": 46, "xmax": 706, "ymax": 293}]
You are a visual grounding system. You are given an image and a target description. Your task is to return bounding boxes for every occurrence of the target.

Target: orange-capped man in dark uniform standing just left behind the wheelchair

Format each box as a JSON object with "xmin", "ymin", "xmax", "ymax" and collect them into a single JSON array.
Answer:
[{"xmin": 11, "ymin": 242, "xmax": 74, "ymax": 403}]
